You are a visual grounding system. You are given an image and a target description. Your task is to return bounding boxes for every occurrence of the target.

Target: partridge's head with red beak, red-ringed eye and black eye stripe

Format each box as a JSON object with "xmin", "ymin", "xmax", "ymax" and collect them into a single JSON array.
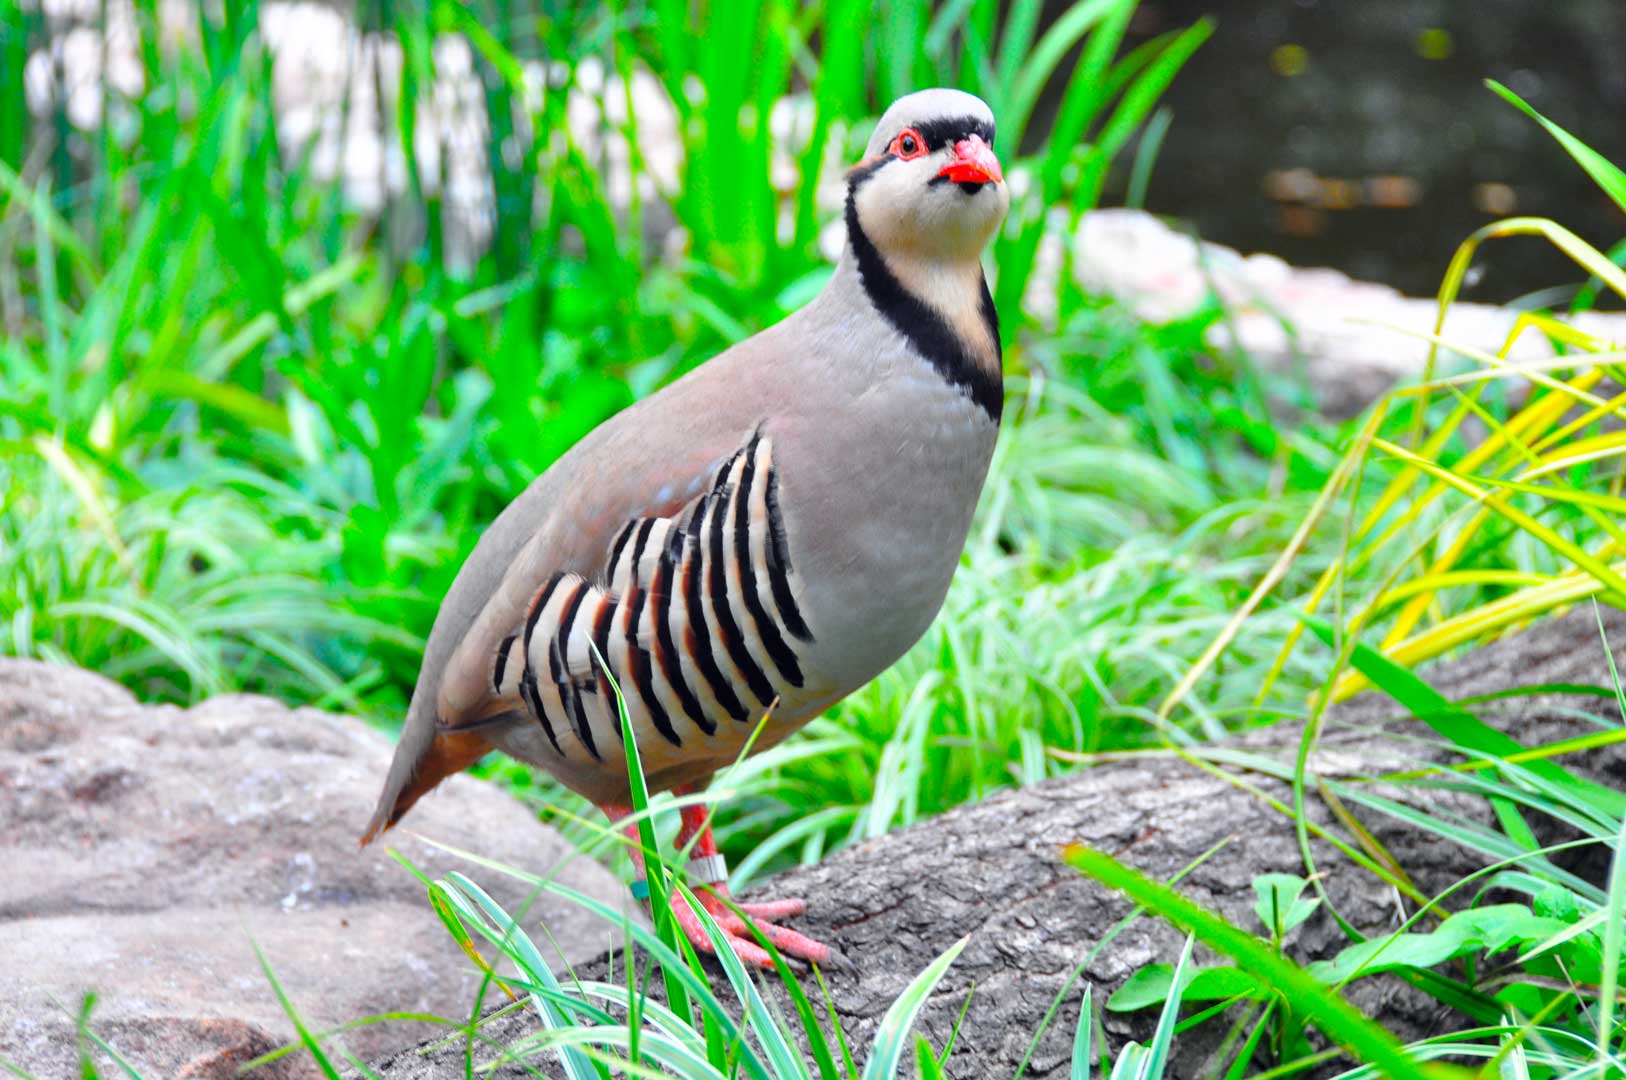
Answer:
[{"xmin": 847, "ymin": 89, "xmax": 1010, "ymax": 260}]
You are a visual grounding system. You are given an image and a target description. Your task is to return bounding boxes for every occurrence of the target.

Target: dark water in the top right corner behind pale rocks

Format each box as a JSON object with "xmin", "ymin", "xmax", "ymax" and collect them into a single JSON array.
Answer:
[{"xmin": 1135, "ymin": 0, "xmax": 1626, "ymax": 301}]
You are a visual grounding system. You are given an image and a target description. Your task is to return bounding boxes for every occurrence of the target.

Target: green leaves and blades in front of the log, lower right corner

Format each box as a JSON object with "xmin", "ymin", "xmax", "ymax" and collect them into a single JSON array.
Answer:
[{"xmin": 1068, "ymin": 601, "xmax": 1626, "ymax": 1080}]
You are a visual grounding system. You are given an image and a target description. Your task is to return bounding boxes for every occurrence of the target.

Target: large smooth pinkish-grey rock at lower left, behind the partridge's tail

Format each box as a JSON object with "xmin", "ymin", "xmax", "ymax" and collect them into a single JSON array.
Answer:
[{"xmin": 0, "ymin": 659, "xmax": 626, "ymax": 1080}]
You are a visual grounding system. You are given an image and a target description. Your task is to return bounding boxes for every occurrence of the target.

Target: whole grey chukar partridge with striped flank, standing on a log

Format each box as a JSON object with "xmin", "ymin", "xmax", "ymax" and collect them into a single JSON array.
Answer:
[{"xmin": 363, "ymin": 89, "xmax": 1010, "ymax": 965}]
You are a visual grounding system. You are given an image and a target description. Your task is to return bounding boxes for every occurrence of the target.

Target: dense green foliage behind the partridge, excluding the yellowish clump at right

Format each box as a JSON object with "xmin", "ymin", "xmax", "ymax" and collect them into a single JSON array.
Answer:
[{"xmin": 0, "ymin": 0, "xmax": 1315, "ymax": 872}]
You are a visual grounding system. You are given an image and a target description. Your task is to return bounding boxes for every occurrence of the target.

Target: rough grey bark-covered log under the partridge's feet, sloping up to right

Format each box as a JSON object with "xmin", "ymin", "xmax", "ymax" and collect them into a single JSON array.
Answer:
[{"xmin": 377, "ymin": 607, "xmax": 1626, "ymax": 1080}]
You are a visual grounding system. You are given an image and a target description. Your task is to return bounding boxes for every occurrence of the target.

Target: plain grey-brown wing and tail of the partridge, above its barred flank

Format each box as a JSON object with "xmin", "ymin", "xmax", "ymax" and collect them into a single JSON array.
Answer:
[{"xmin": 363, "ymin": 378, "xmax": 761, "ymax": 843}]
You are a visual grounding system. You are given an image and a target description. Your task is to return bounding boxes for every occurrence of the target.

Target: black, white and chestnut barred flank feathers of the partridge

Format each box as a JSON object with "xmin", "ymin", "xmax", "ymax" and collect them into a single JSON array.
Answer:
[{"xmin": 470, "ymin": 433, "xmax": 813, "ymax": 764}]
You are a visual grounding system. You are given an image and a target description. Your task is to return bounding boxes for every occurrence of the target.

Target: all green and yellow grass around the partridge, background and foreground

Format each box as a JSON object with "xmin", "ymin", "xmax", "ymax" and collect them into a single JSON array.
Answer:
[{"xmin": 9, "ymin": 0, "xmax": 1626, "ymax": 1080}]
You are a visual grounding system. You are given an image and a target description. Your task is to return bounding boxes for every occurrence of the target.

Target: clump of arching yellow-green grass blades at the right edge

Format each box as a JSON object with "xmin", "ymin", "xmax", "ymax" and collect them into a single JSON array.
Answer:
[{"xmin": 1161, "ymin": 85, "xmax": 1626, "ymax": 716}]
